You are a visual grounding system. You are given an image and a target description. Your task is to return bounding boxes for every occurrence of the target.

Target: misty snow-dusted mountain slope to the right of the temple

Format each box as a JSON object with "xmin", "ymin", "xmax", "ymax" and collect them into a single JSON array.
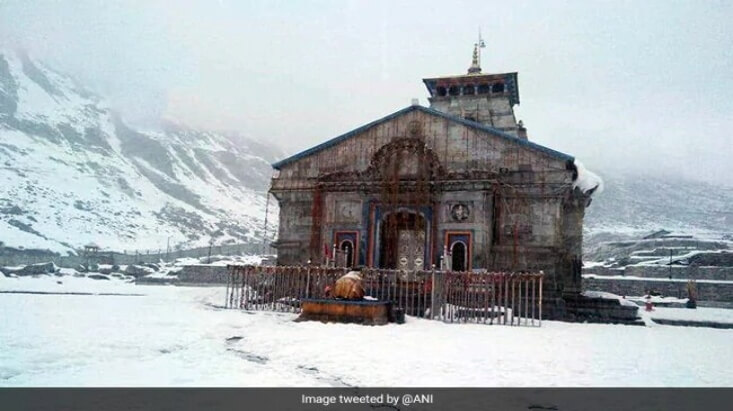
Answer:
[{"xmin": 584, "ymin": 170, "xmax": 733, "ymax": 243}]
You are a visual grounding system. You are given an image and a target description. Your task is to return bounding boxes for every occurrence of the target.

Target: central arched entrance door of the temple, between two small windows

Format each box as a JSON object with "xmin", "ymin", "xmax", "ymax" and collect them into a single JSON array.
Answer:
[{"xmin": 379, "ymin": 211, "xmax": 427, "ymax": 270}]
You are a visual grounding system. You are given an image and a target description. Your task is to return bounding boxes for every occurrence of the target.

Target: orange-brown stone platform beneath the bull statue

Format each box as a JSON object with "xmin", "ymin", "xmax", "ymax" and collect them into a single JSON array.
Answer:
[{"xmin": 295, "ymin": 298, "xmax": 391, "ymax": 325}]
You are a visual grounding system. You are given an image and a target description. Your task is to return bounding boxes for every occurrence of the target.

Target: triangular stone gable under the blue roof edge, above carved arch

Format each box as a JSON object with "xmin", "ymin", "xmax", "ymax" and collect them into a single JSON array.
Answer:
[{"xmin": 272, "ymin": 110, "xmax": 569, "ymax": 186}]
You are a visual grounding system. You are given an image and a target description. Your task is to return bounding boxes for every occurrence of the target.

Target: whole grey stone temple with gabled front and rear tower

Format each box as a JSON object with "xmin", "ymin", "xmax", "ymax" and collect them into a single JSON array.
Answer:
[{"xmin": 271, "ymin": 47, "xmax": 593, "ymax": 316}]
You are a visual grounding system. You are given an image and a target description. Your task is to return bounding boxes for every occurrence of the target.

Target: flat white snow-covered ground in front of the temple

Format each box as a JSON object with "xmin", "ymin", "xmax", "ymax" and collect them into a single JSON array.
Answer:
[{"xmin": 0, "ymin": 276, "xmax": 733, "ymax": 386}]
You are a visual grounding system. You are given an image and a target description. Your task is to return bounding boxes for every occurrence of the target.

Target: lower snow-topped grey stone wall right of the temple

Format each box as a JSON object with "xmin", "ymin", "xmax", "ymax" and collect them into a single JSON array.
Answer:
[{"xmin": 583, "ymin": 277, "xmax": 733, "ymax": 303}]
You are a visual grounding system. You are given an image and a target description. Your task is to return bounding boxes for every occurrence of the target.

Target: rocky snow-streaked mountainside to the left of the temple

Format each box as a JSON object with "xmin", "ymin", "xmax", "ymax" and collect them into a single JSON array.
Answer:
[{"xmin": 0, "ymin": 51, "xmax": 280, "ymax": 253}]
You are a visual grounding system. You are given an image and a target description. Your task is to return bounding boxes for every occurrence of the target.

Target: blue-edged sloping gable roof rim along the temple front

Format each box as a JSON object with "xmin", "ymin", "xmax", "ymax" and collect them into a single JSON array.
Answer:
[{"xmin": 272, "ymin": 105, "xmax": 574, "ymax": 170}]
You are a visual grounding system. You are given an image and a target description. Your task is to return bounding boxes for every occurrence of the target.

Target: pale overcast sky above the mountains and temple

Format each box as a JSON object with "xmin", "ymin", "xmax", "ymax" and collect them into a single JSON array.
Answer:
[{"xmin": 0, "ymin": 0, "xmax": 733, "ymax": 184}]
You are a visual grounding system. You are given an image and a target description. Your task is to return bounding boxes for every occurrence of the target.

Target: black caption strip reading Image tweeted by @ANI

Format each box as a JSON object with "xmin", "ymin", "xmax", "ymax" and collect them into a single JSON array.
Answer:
[{"xmin": 0, "ymin": 388, "xmax": 733, "ymax": 411}]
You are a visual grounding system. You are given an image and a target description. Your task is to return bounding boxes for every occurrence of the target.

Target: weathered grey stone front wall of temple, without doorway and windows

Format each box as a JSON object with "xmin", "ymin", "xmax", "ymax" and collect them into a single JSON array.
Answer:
[{"xmin": 271, "ymin": 109, "xmax": 588, "ymax": 308}]
